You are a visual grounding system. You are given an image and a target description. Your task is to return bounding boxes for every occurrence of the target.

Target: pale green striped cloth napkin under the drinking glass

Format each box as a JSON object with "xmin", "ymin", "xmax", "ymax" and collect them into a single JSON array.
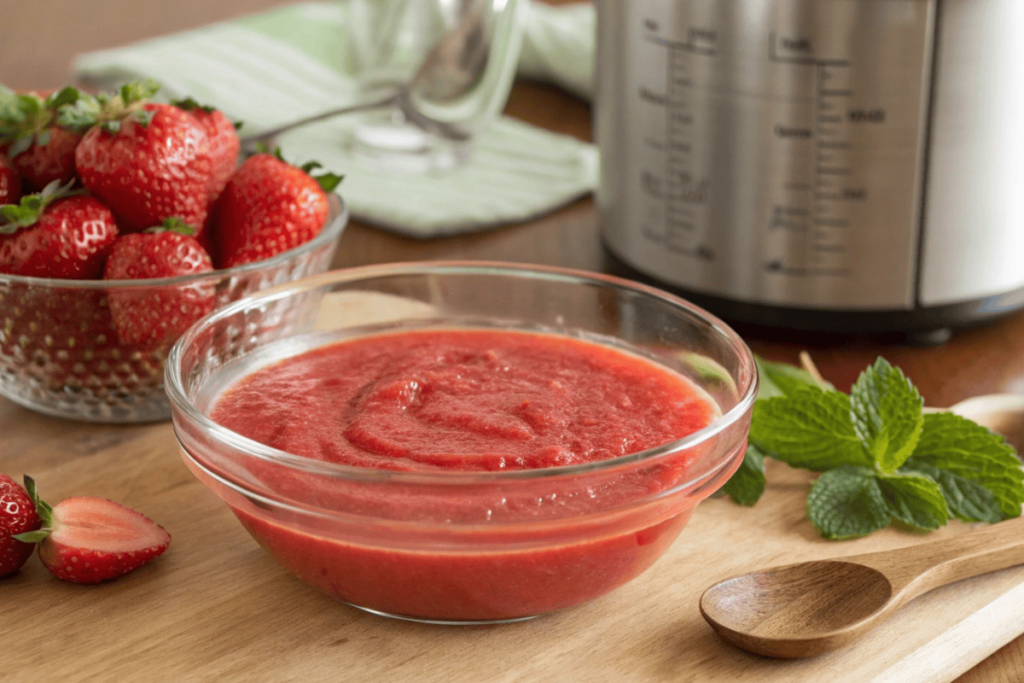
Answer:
[{"xmin": 74, "ymin": 0, "xmax": 598, "ymax": 238}]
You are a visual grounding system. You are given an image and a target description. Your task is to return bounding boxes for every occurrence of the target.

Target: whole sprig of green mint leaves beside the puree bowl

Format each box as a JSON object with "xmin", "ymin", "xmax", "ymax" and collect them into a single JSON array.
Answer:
[{"xmin": 724, "ymin": 358, "xmax": 1024, "ymax": 539}]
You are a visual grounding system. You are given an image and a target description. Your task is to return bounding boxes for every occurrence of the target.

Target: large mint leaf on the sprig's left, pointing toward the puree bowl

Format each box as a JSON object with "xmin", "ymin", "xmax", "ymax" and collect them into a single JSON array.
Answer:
[{"xmin": 751, "ymin": 386, "xmax": 873, "ymax": 472}]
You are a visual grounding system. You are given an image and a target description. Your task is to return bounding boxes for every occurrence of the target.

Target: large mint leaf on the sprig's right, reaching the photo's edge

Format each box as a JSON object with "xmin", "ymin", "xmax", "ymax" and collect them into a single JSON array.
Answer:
[{"xmin": 906, "ymin": 413, "xmax": 1024, "ymax": 519}]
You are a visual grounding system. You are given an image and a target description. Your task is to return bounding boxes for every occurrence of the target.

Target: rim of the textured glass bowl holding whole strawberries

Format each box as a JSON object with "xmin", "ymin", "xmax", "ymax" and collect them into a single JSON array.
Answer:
[{"xmin": 0, "ymin": 191, "xmax": 349, "ymax": 291}]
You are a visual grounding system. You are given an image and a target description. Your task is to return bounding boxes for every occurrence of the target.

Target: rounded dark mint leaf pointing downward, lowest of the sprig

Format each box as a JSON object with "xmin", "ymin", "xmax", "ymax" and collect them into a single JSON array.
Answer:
[{"xmin": 807, "ymin": 466, "xmax": 892, "ymax": 539}]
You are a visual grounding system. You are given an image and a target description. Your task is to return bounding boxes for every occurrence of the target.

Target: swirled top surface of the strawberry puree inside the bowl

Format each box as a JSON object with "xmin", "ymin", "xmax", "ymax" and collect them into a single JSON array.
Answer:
[{"xmin": 213, "ymin": 331, "xmax": 717, "ymax": 471}]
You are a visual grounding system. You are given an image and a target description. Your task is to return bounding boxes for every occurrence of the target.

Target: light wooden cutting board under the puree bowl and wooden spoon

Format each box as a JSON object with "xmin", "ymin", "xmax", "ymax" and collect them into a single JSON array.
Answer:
[{"xmin": 0, "ymin": 294, "xmax": 1024, "ymax": 683}]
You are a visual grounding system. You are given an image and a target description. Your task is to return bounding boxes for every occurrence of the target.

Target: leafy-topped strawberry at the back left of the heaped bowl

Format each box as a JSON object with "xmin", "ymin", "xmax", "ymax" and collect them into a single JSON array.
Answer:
[{"xmin": 0, "ymin": 87, "xmax": 88, "ymax": 193}]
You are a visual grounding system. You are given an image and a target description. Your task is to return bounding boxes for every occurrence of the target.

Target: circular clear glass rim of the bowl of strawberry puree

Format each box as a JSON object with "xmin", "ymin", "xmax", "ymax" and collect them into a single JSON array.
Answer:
[{"xmin": 164, "ymin": 260, "xmax": 760, "ymax": 489}]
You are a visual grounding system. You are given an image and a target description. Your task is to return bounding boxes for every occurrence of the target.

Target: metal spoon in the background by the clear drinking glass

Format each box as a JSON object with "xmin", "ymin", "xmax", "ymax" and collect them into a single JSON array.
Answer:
[{"xmin": 240, "ymin": 1, "xmax": 493, "ymax": 155}]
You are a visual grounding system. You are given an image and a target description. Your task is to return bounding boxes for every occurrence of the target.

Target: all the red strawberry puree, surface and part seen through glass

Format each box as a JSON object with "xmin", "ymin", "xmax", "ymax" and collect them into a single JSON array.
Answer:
[{"xmin": 212, "ymin": 330, "xmax": 719, "ymax": 620}]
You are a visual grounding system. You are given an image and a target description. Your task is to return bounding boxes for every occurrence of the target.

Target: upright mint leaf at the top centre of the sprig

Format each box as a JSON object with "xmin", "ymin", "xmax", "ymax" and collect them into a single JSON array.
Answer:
[{"xmin": 850, "ymin": 357, "xmax": 925, "ymax": 472}]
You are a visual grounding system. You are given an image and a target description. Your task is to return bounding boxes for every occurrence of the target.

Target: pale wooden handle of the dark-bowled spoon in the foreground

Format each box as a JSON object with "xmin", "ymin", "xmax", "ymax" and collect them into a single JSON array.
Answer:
[{"xmin": 845, "ymin": 517, "xmax": 1024, "ymax": 600}]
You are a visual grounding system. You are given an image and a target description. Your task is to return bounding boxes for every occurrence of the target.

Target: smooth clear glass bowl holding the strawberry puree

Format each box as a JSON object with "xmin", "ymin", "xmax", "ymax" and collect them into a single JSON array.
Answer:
[{"xmin": 167, "ymin": 262, "xmax": 757, "ymax": 624}]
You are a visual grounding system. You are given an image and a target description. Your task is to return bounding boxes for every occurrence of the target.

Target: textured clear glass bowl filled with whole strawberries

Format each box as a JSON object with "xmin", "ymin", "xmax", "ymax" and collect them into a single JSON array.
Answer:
[{"xmin": 0, "ymin": 195, "xmax": 348, "ymax": 423}]
